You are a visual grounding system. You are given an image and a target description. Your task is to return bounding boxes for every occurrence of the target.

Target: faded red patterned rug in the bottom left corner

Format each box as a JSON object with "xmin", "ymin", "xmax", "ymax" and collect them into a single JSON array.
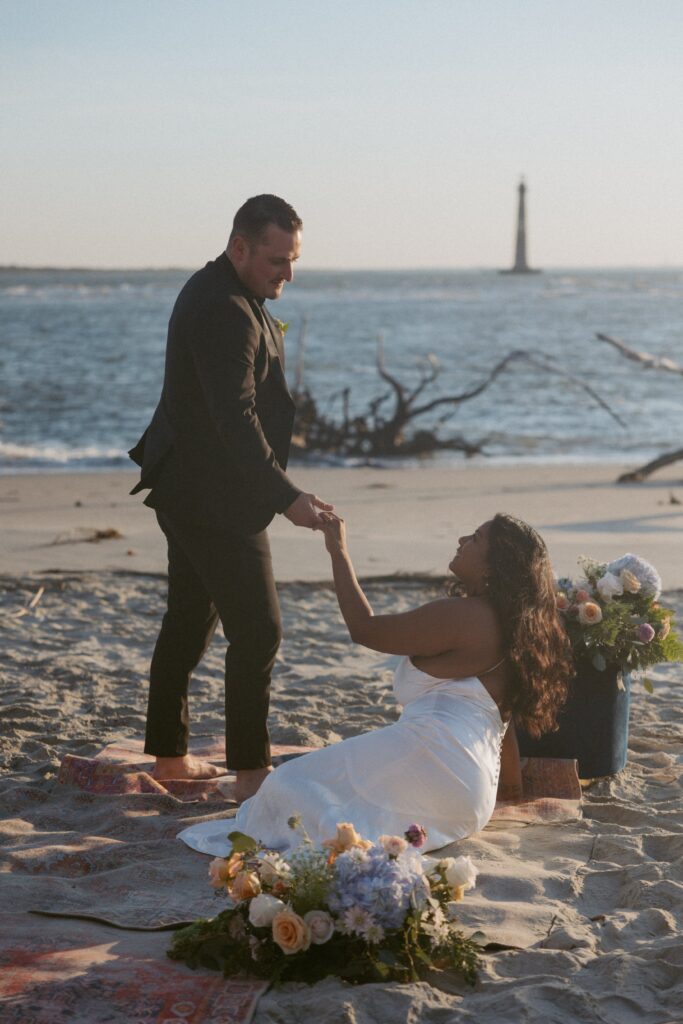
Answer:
[{"xmin": 0, "ymin": 914, "xmax": 267, "ymax": 1024}]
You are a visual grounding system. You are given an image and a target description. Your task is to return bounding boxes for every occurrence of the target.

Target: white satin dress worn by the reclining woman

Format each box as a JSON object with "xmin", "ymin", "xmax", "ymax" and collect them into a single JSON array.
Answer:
[{"xmin": 178, "ymin": 657, "xmax": 506, "ymax": 856}]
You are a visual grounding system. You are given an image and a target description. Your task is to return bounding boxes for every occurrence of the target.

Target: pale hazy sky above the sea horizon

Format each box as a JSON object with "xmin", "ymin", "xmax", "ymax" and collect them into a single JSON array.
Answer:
[{"xmin": 0, "ymin": 0, "xmax": 683, "ymax": 267}]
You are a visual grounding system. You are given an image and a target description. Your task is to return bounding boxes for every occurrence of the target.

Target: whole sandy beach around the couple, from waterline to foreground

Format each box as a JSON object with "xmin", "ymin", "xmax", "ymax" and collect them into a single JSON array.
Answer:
[{"xmin": 0, "ymin": 466, "xmax": 683, "ymax": 1024}]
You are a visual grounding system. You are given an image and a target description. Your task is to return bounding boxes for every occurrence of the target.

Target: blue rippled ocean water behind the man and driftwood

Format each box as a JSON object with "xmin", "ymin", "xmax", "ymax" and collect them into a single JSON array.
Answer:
[{"xmin": 0, "ymin": 268, "xmax": 683, "ymax": 472}]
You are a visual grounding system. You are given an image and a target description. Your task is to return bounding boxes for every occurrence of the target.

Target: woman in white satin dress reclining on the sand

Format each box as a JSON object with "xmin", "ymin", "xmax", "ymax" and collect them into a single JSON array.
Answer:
[{"xmin": 182, "ymin": 513, "xmax": 571, "ymax": 855}]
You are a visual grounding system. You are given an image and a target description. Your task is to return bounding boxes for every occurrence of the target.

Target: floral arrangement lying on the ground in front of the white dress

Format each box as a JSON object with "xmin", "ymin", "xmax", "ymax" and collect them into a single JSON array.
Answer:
[{"xmin": 169, "ymin": 817, "xmax": 479, "ymax": 984}]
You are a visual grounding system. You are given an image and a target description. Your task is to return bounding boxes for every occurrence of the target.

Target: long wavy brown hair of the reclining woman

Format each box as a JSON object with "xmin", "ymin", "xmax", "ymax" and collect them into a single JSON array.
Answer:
[{"xmin": 486, "ymin": 513, "xmax": 574, "ymax": 736}]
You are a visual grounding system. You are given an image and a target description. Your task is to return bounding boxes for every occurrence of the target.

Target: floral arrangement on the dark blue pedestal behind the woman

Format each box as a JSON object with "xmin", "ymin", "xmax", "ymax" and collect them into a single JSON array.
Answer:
[{"xmin": 557, "ymin": 554, "xmax": 683, "ymax": 692}]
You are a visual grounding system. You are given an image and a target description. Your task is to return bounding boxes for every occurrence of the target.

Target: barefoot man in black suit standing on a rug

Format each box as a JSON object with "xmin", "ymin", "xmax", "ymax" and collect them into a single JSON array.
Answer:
[{"xmin": 130, "ymin": 196, "xmax": 332, "ymax": 800}]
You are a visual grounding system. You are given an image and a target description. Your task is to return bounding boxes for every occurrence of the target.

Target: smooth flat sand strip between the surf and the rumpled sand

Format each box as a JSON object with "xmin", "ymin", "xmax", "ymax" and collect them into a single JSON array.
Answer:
[{"xmin": 0, "ymin": 462, "xmax": 683, "ymax": 590}]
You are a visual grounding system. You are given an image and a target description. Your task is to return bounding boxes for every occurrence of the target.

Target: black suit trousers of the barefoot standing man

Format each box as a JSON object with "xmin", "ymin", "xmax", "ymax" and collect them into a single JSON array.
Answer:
[{"xmin": 144, "ymin": 512, "xmax": 282, "ymax": 771}]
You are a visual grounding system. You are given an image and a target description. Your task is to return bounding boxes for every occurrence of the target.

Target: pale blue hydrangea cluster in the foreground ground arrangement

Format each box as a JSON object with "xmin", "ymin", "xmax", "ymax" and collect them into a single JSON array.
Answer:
[{"xmin": 328, "ymin": 847, "xmax": 429, "ymax": 928}]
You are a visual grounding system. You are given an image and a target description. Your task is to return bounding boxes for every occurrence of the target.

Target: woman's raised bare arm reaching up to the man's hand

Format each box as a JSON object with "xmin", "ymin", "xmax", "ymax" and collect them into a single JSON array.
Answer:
[{"xmin": 321, "ymin": 513, "xmax": 484, "ymax": 655}]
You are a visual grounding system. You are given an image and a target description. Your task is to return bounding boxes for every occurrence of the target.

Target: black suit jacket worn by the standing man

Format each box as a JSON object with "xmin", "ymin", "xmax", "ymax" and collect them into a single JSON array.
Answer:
[{"xmin": 129, "ymin": 253, "xmax": 300, "ymax": 534}]
